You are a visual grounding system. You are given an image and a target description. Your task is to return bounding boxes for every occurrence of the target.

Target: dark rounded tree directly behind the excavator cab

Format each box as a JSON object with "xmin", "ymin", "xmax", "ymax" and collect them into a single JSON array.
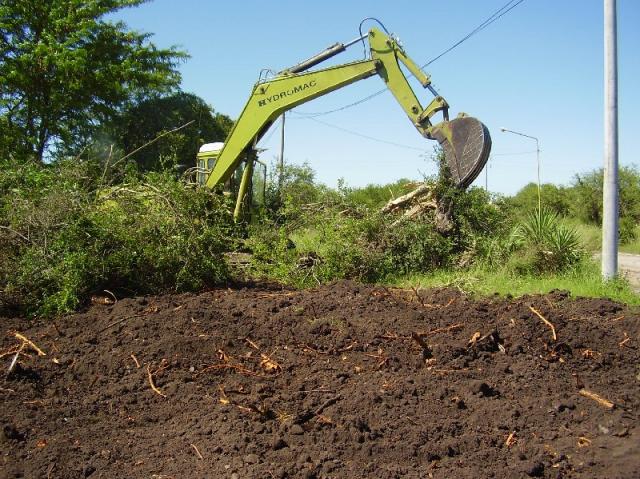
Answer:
[{"xmin": 115, "ymin": 92, "xmax": 233, "ymax": 171}]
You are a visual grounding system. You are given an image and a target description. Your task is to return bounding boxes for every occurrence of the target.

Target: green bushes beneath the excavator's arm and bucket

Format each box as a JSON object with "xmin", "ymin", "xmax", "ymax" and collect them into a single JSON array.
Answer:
[{"xmin": 247, "ymin": 161, "xmax": 507, "ymax": 286}]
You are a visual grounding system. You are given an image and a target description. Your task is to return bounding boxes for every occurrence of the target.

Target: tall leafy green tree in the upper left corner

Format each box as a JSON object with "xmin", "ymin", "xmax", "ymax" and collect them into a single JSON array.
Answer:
[{"xmin": 0, "ymin": 0, "xmax": 187, "ymax": 161}]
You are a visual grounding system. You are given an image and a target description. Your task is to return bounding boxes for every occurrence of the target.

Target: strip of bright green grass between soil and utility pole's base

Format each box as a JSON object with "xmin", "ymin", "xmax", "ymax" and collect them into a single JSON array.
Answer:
[{"xmin": 393, "ymin": 261, "xmax": 640, "ymax": 305}]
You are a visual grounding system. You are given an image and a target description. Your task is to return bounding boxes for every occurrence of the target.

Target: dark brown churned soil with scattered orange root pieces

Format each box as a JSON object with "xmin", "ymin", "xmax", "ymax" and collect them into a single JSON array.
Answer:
[{"xmin": 0, "ymin": 282, "xmax": 640, "ymax": 479}]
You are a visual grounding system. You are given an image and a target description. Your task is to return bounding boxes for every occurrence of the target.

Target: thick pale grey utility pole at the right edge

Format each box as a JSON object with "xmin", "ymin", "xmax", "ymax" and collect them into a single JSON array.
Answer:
[{"xmin": 602, "ymin": 0, "xmax": 618, "ymax": 280}]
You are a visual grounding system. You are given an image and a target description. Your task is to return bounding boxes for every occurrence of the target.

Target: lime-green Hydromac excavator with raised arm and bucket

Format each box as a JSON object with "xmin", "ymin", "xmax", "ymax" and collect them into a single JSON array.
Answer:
[{"xmin": 197, "ymin": 27, "xmax": 491, "ymax": 220}]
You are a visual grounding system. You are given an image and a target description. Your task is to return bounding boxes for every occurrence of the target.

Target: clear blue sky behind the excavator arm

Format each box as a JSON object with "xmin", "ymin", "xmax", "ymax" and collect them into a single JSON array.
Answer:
[{"xmin": 112, "ymin": 0, "xmax": 640, "ymax": 194}]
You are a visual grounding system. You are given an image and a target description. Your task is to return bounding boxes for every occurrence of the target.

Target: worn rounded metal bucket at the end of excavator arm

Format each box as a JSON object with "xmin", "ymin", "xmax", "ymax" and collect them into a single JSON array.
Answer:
[{"xmin": 430, "ymin": 116, "xmax": 491, "ymax": 188}]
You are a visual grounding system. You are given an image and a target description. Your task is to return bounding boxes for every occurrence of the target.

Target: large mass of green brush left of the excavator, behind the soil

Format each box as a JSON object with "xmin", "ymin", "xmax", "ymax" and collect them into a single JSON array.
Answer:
[{"xmin": 0, "ymin": 156, "xmax": 234, "ymax": 315}]
